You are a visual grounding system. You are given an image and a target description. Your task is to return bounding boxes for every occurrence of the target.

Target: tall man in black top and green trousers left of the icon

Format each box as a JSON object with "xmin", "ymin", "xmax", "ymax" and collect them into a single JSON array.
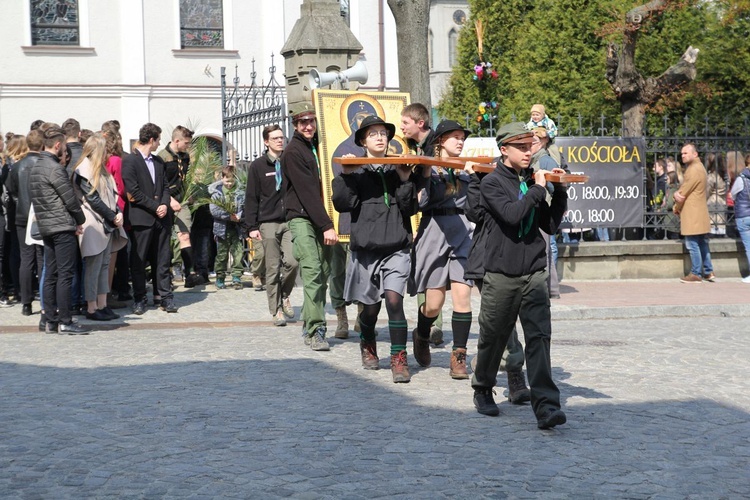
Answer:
[{"xmin": 281, "ymin": 102, "xmax": 339, "ymax": 351}]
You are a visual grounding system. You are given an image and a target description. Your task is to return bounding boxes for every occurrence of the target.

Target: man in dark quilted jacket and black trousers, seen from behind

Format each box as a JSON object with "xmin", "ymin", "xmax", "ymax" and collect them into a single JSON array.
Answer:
[{"xmin": 29, "ymin": 124, "xmax": 90, "ymax": 335}]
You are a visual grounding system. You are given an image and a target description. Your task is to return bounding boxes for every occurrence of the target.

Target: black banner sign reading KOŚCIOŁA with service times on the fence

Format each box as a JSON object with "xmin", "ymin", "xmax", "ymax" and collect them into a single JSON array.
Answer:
[{"xmin": 555, "ymin": 137, "xmax": 646, "ymax": 228}]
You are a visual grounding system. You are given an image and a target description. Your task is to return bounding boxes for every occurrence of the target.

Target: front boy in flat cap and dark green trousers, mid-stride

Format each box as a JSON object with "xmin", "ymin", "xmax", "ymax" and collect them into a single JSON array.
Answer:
[{"xmin": 471, "ymin": 122, "xmax": 567, "ymax": 429}]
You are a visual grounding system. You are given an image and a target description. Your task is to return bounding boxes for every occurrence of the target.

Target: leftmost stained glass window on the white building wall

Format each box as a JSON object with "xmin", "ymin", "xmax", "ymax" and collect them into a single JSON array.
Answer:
[{"xmin": 31, "ymin": 0, "xmax": 80, "ymax": 45}]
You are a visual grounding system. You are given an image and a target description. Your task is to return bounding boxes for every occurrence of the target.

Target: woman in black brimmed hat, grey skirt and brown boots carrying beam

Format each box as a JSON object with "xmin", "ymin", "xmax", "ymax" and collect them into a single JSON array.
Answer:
[{"xmin": 332, "ymin": 116, "xmax": 418, "ymax": 383}]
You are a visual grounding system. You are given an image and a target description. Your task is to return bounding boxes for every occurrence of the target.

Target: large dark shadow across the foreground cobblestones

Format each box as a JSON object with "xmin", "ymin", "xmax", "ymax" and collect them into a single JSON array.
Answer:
[{"xmin": 0, "ymin": 353, "xmax": 750, "ymax": 498}]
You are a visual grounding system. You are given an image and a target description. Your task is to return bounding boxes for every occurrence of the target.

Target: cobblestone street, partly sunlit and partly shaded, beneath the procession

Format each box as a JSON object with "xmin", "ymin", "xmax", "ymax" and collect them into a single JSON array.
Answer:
[{"xmin": 0, "ymin": 283, "xmax": 750, "ymax": 499}]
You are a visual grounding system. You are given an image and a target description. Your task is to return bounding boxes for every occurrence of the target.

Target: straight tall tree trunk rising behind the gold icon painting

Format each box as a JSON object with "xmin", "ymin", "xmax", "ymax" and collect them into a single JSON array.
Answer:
[{"xmin": 388, "ymin": 0, "xmax": 432, "ymax": 109}]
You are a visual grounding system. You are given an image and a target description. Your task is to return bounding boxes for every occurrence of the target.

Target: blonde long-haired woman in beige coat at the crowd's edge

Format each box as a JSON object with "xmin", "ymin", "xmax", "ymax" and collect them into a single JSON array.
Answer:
[{"xmin": 73, "ymin": 132, "xmax": 125, "ymax": 321}]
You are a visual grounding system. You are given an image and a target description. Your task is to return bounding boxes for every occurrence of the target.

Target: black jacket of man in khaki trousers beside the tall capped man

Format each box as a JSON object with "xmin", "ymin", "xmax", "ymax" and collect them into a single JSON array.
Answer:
[{"xmin": 245, "ymin": 153, "xmax": 284, "ymax": 231}]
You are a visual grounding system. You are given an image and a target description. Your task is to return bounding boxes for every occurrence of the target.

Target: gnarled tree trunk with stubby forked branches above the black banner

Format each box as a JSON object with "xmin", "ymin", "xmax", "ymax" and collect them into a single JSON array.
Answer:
[{"xmin": 605, "ymin": 0, "xmax": 698, "ymax": 137}]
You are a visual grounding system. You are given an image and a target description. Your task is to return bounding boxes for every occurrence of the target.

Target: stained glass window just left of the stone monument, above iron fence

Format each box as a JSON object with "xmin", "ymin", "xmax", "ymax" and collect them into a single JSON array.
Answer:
[{"xmin": 180, "ymin": 0, "xmax": 224, "ymax": 49}]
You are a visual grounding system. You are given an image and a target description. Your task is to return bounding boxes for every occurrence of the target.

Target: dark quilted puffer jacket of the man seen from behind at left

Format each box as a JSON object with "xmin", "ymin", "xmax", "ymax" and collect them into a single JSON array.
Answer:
[{"xmin": 29, "ymin": 151, "xmax": 86, "ymax": 237}]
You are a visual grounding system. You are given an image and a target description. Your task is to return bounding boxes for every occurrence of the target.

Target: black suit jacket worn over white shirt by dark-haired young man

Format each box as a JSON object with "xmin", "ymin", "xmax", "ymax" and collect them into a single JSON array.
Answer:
[{"xmin": 122, "ymin": 151, "xmax": 171, "ymax": 226}]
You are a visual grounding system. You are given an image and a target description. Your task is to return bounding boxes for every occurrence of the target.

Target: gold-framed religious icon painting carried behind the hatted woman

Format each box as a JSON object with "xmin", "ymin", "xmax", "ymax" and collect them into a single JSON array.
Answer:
[{"xmin": 313, "ymin": 89, "xmax": 417, "ymax": 243}]
